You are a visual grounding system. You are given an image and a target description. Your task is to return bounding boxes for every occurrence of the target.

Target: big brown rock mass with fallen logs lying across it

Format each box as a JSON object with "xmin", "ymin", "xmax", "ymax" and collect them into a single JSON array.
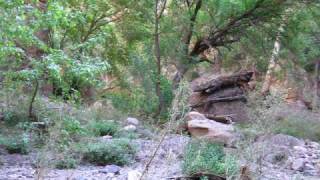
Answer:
[{"xmin": 189, "ymin": 72, "xmax": 253, "ymax": 123}]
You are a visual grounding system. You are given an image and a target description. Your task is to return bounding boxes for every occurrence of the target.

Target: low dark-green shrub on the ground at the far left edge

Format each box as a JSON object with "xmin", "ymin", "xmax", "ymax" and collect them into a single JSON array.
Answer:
[{"xmin": 2, "ymin": 136, "xmax": 30, "ymax": 154}]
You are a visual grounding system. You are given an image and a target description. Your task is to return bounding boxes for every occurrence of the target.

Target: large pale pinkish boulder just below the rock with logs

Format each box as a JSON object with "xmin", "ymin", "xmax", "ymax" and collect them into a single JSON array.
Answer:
[{"xmin": 186, "ymin": 112, "xmax": 236, "ymax": 146}]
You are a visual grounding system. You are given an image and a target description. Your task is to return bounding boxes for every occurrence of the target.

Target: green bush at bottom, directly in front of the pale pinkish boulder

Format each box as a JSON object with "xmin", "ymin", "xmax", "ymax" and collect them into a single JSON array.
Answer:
[{"xmin": 182, "ymin": 141, "xmax": 237, "ymax": 176}]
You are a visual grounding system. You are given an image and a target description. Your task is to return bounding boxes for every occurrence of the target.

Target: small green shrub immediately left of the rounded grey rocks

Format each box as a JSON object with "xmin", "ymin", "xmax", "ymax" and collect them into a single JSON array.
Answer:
[{"xmin": 91, "ymin": 121, "xmax": 120, "ymax": 136}]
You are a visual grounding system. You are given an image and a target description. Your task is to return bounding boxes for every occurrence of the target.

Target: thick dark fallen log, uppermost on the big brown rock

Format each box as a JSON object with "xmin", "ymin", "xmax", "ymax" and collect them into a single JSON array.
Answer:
[{"xmin": 191, "ymin": 72, "xmax": 253, "ymax": 93}]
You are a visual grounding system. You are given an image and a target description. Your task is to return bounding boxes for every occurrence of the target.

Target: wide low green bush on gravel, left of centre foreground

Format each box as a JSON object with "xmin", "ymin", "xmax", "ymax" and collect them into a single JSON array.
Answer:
[{"xmin": 83, "ymin": 139, "xmax": 137, "ymax": 166}]
